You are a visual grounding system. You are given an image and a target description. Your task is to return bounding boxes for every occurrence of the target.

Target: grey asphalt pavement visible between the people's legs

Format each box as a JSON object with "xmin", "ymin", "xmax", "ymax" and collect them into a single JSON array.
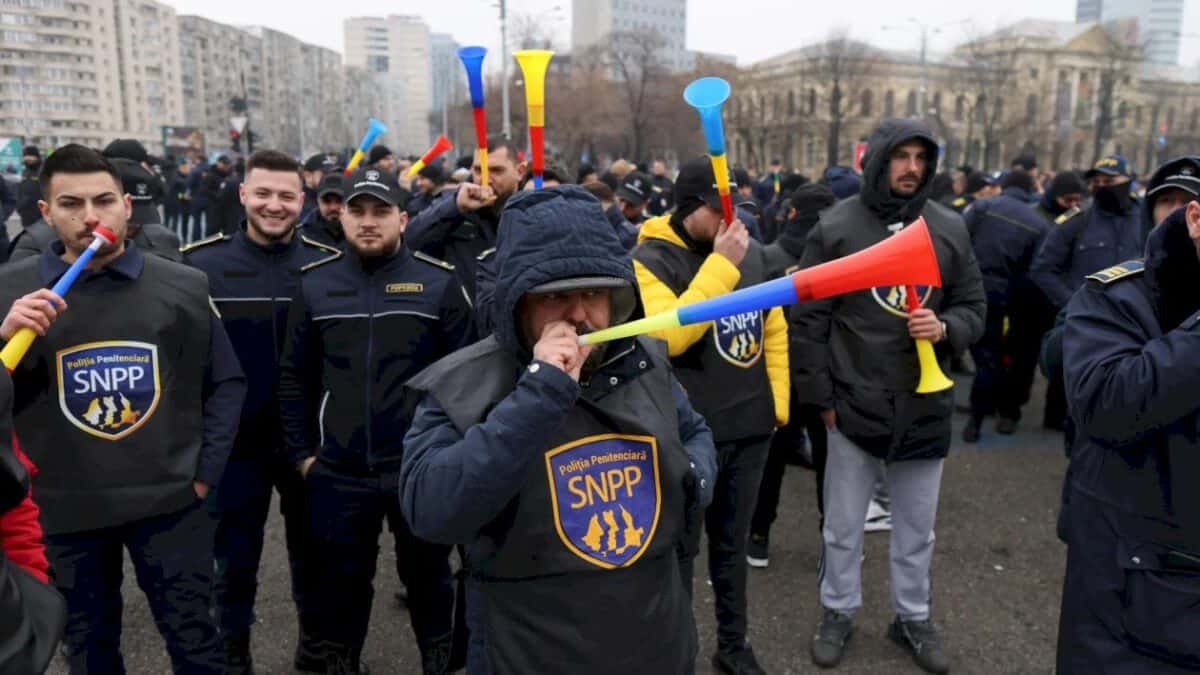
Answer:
[{"xmin": 50, "ymin": 381, "xmax": 1066, "ymax": 675}]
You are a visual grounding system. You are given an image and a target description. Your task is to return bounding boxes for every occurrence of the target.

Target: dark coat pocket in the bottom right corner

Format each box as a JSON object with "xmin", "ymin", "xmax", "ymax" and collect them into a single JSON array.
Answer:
[{"xmin": 1117, "ymin": 542, "xmax": 1200, "ymax": 668}]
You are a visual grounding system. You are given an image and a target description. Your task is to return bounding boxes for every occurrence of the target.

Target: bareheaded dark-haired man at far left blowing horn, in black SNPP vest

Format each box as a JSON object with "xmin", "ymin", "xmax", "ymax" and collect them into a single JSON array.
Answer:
[{"xmin": 0, "ymin": 145, "xmax": 246, "ymax": 673}]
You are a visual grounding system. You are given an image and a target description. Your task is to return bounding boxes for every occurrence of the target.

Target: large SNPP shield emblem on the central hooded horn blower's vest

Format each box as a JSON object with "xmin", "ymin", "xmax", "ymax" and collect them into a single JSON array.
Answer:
[{"xmin": 546, "ymin": 434, "xmax": 662, "ymax": 569}]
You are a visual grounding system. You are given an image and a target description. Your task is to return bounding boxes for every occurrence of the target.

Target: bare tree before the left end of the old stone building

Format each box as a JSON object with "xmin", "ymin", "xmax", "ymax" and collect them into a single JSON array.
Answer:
[{"xmin": 806, "ymin": 28, "xmax": 878, "ymax": 166}]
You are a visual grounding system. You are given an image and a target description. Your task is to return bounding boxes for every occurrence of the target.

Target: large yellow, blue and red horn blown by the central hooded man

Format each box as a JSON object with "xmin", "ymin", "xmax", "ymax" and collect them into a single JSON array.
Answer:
[{"xmin": 580, "ymin": 219, "xmax": 942, "ymax": 345}]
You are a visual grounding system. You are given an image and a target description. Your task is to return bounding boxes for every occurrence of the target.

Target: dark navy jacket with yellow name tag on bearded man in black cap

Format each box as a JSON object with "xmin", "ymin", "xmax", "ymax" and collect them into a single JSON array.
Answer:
[{"xmin": 278, "ymin": 244, "xmax": 473, "ymax": 473}]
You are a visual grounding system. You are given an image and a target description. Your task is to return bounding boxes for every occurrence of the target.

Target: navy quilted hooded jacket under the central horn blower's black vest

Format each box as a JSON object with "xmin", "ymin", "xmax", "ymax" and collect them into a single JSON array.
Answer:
[{"xmin": 400, "ymin": 185, "xmax": 716, "ymax": 544}]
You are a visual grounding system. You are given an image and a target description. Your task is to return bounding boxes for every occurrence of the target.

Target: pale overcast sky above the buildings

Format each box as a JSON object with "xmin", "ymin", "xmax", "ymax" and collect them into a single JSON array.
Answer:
[{"xmin": 166, "ymin": 0, "xmax": 1200, "ymax": 66}]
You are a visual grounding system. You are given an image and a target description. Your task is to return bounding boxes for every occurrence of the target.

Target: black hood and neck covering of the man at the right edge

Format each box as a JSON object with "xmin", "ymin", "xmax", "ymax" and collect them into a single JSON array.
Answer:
[{"xmin": 1145, "ymin": 209, "xmax": 1200, "ymax": 333}]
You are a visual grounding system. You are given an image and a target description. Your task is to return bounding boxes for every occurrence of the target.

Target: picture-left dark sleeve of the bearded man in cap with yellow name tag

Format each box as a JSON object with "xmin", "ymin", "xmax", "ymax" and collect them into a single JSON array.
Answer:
[{"xmin": 278, "ymin": 282, "xmax": 322, "ymax": 464}]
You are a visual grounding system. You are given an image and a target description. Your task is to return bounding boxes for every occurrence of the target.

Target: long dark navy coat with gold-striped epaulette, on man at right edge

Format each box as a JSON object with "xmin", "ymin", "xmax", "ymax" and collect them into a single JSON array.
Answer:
[{"xmin": 1057, "ymin": 196, "xmax": 1200, "ymax": 674}]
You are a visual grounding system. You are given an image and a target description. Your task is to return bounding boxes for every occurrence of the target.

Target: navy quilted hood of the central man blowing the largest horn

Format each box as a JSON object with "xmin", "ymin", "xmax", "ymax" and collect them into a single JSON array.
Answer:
[{"xmin": 494, "ymin": 185, "xmax": 640, "ymax": 362}]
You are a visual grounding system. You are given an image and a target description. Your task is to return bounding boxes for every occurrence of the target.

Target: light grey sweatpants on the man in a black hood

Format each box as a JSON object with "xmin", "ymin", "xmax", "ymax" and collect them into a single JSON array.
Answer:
[{"xmin": 821, "ymin": 429, "xmax": 943, "ymax": 621}]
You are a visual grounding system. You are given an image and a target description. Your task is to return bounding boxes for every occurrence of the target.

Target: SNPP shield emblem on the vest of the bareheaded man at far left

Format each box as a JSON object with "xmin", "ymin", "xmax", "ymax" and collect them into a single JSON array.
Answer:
[{"xmin": 55, "ymin": 341, "xmax": 161, "ymax": 441}]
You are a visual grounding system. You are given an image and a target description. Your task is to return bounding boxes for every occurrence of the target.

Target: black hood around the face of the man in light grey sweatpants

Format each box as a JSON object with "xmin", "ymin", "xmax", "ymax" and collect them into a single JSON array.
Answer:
[{"xmin": 859, "ymin": 118, "xmax": 937, "ymax": 225}]
